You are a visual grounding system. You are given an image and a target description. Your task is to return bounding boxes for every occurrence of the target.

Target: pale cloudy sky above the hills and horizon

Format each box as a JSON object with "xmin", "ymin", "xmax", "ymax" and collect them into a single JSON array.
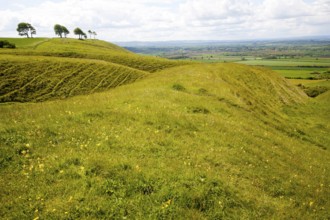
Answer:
[{"xmin": 0, "ymin": 0, "xmax": 330, "ymax": 41}]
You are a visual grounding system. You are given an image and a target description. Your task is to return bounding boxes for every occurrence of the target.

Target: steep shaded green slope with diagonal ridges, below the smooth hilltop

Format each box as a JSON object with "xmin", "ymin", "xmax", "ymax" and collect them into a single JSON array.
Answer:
[{"xmin": 0, "ymin": 55, "xmax": 148, "ymax": 102}]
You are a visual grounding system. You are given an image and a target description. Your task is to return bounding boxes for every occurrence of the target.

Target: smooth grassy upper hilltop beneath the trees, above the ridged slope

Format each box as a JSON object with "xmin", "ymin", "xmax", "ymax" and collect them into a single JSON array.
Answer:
[{"xmin": 0, "ymin": 38, "xmax": 187, "ymax": 72}]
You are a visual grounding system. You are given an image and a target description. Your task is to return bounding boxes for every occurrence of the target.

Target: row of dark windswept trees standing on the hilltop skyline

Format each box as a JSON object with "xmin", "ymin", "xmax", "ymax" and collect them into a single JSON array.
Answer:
[{"xmin": 16, "ymin": 22, "xmax": 97, "ymax": 40}]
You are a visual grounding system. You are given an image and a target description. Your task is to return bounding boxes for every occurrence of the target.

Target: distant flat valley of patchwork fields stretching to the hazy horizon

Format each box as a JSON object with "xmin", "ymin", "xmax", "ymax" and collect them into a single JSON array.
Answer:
[{"xmin": 125, "ymin": 40, "xmax": 330, "ymax": 79}]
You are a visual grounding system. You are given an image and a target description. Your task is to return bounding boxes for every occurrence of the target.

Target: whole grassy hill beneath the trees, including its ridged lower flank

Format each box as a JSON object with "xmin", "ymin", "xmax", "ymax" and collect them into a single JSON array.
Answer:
[{"xmin": 0, "ymin": 38, "xmax": 189, "ymax": 102}]
